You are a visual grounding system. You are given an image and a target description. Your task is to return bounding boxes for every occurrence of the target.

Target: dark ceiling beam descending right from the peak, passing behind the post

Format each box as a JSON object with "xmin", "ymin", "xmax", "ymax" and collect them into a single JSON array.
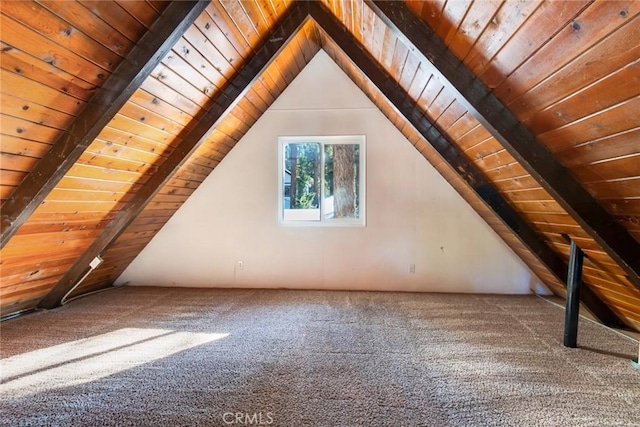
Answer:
[{"xmin": 309, "ymin": 2, "xmax": 623, "ymax": 327}]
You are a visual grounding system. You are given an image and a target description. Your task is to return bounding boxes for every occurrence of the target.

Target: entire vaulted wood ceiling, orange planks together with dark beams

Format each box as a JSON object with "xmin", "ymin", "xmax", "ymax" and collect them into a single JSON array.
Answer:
[{"xmin": 0, "ymin": 0, "xmax": 640, "ymax": 330}]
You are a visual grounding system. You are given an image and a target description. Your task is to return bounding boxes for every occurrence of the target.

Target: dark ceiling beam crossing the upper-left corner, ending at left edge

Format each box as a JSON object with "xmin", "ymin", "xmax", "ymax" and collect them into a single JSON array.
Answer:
[{"xmin": 0, "ymin": 0, "xmax": 209, "ymax": 248}]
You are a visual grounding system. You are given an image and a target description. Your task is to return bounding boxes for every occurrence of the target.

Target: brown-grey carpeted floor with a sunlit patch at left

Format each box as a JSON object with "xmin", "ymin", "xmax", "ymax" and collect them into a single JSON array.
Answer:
[{"xmin": 0, "ymin": 287, "xmax": 640, "ymax": 426}]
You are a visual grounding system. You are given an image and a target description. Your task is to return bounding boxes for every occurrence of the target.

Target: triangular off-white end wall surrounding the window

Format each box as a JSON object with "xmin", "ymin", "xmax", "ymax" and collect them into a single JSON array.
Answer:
[{"xmin": 117, "ymin": 51, "xmax": 540, "ymax": 293}]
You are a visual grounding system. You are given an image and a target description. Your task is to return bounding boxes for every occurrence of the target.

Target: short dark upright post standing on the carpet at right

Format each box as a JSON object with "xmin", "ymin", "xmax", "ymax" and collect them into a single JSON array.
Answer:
[{"xmin": 563, "ymin": 240, "xmax": 584, "ymax": 348}]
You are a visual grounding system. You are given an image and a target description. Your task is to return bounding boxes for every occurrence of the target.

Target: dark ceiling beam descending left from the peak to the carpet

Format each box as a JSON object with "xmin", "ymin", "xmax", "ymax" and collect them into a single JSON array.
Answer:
[{"xmin": 39, "ymin": 3, "xmax": 308, "ymax": 308}]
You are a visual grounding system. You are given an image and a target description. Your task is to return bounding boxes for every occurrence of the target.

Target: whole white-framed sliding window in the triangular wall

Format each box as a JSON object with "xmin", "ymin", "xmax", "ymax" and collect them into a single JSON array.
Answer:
[{"xmin": 278, "ymin": 135, "xmax": 365, "ymax": 226}]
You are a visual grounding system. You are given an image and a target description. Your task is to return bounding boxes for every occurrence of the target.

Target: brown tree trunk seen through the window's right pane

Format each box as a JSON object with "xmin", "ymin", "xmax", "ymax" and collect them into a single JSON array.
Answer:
[{"xmin": 333, "ymin": 144, "xmax": 356, "ymax": 218}]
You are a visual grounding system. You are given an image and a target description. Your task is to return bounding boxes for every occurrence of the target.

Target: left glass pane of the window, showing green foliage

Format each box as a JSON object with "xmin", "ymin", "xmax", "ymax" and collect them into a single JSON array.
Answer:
[{"xmin": 282, "ymin": 143, "xmax": 321, "ymax": 221}]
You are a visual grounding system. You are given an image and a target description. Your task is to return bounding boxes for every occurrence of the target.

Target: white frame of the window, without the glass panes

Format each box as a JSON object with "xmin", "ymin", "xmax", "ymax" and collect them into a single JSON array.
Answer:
[{"xmin": 277, "ymin": 135, "xmax": 367, "ymax": 227}]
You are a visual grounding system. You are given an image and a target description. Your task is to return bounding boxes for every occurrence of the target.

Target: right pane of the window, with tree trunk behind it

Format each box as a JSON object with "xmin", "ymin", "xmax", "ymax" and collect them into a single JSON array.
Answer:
[{"xmin": 322, "ymin": 144, "xmax": 360, "ymax": 219}]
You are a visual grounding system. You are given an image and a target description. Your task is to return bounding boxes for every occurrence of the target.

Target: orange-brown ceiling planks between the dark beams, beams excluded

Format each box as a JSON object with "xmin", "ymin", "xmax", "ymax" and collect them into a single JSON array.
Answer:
[{"xmin": 0, "ymin": 0, "xmax": 640, "ymax": 330}]
